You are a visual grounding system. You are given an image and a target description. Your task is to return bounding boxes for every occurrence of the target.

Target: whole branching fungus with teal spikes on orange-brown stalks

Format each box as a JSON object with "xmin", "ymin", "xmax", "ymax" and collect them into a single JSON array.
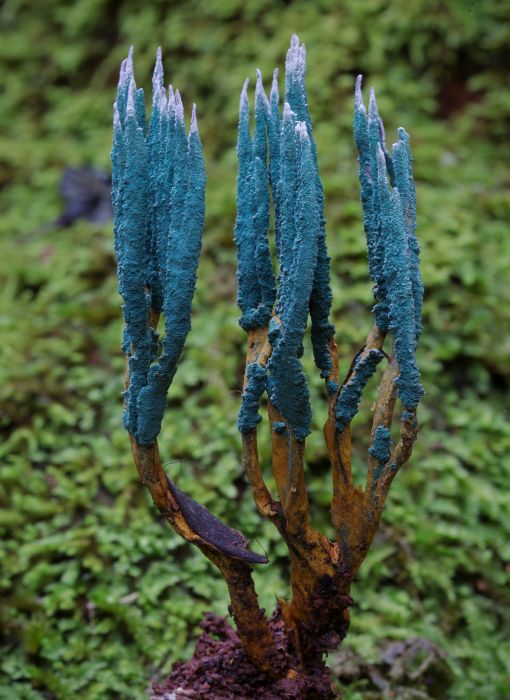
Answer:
[{"xmin": 112, "ymin": 35, "xmax": 423, "ymax": 697}]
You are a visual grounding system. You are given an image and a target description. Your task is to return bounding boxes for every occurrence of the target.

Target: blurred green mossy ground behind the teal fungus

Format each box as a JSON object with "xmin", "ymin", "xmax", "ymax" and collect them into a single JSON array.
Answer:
[{"xmin": 0, "ymin": 0, "xmax": 510, "ymax": 700}]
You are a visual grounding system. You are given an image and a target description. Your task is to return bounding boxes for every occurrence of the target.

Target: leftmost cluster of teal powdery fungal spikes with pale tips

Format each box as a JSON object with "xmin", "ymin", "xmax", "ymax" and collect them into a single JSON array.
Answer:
[{"xmin": 112, "ymin": 49, "xmax": 206, "ymax": 445}]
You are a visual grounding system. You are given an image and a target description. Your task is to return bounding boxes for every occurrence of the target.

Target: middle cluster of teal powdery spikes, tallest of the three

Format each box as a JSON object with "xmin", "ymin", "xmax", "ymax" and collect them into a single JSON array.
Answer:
[{"xmin": 235, "ymin": 35, "xmax": 336, "ymax": 440}]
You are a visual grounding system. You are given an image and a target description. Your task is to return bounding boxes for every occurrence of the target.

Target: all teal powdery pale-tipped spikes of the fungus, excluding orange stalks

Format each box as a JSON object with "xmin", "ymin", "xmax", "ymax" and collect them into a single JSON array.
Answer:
[{"xmin": 112, "ymin": 35, "xmax": 423, "ymax": 449}]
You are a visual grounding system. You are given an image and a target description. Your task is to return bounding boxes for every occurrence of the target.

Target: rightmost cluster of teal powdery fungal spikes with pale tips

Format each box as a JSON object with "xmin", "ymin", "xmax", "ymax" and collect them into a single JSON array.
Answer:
[{"xmin": 354, "ymin": 77, "xmax": 423, "ymax": 409}]
